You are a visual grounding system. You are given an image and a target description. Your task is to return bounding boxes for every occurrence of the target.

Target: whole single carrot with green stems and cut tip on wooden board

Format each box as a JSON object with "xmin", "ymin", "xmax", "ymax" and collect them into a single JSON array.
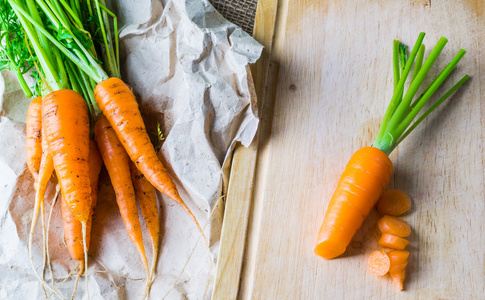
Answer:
[{"xmin": 314, "ymin": 33, "xmax": 469, "ymax": 259}]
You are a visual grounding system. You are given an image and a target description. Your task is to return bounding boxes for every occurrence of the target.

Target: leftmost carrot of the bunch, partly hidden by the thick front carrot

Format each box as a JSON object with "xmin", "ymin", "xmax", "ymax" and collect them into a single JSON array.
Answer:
[{"xmin": 25, "ymin": 97, "xmax": 42, "ymax": 179}]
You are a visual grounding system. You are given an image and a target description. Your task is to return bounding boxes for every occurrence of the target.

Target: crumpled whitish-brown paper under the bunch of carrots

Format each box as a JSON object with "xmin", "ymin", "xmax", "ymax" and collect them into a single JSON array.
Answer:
[{"xmin": 0, "ymin": 0, "xmax": 262, "ymax": 299}]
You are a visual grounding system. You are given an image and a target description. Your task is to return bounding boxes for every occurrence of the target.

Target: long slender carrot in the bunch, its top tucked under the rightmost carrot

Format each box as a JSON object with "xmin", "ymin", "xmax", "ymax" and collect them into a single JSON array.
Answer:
[{"xmin": 95, "ymin": 115, "xmax": 150, "ymax": 279}]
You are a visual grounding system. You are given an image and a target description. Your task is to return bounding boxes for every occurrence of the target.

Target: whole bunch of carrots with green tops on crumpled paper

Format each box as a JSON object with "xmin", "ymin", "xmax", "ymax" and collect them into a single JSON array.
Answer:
[{"xmin": 0, "ymin": 0, "xmax": 205, "ymax": 298}]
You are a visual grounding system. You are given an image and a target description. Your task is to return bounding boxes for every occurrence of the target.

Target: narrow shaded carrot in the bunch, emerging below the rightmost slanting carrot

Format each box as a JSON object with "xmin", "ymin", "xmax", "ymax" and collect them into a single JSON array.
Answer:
[{"xmin": 130, "ymin": 161, "xmax": 160, "ymax": 293}]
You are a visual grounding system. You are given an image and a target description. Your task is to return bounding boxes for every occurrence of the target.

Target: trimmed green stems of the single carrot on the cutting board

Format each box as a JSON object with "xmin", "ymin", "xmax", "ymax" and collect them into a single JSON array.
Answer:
[{"xmin": 372, "ymin": 32, "xmax": 469, "ymax": 155}]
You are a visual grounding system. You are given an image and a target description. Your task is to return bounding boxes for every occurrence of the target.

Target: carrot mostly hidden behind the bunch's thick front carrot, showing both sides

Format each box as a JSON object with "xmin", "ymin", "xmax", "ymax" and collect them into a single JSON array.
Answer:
[{"xmin": 61, "ymin": 140, "xmax": 103, "ymax": 260}]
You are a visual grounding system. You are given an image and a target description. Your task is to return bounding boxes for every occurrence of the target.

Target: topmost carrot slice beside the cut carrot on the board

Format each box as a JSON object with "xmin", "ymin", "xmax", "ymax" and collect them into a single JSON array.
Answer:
[{"xmin": 377, "ymin": 190, "xmax": 411, "ymax": 217}]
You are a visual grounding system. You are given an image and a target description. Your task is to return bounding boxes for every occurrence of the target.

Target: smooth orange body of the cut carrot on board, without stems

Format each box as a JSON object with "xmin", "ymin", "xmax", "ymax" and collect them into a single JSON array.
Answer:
[{"xmin": 315, "ymin": 147, "xmax": 393, "ymax": 259}]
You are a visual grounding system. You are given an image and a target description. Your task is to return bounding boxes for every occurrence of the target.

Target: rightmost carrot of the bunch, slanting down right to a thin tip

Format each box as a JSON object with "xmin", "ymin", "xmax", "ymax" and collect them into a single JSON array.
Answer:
[{"xmin": 94, "ymin": 78, "xmax": 202, "ymax": 232}]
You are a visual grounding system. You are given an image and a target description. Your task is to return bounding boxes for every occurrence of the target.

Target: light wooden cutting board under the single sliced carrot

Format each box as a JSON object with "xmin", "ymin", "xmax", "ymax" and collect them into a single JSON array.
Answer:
[{"xmin": 213, "ymin": 0, "xmax": 485, "ymax": 299}]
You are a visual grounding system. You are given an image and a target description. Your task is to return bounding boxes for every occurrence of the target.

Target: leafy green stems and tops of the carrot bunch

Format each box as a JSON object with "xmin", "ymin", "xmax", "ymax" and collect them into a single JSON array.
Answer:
[{"xmin": 0, "ymin": 0, "xmax": 120, "ymax": 135}]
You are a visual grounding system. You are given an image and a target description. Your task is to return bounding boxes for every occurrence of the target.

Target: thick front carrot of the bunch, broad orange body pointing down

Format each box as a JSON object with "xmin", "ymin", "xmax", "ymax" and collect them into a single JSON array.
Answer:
[{"xmin": 42, "ymin": 90, "xmax": 91, "ymax": 222}]
